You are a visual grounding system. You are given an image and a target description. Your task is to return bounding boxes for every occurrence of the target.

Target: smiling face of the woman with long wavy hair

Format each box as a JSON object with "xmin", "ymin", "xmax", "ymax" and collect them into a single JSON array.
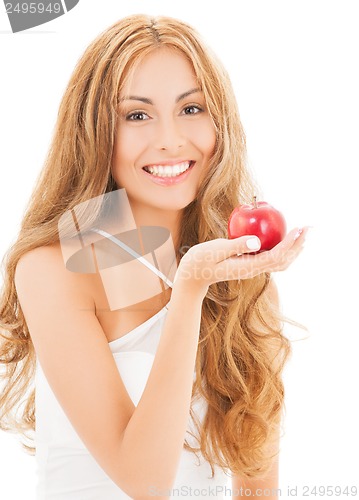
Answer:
[{"xmin": 112, "ymin": 48, "xmax": 216, "ymax": 216}]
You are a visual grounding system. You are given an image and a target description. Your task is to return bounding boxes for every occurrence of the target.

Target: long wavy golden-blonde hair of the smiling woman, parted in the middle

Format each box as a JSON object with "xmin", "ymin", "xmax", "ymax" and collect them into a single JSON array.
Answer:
[{"xmin": 0, "ymin": 15, "xmax": 296, "ymax": 477}]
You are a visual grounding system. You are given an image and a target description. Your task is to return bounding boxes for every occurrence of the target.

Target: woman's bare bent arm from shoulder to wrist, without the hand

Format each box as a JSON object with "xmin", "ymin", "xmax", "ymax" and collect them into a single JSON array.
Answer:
[{"xmin": 15, "ymin": 247, "xmax": 205, "ymax": 499}]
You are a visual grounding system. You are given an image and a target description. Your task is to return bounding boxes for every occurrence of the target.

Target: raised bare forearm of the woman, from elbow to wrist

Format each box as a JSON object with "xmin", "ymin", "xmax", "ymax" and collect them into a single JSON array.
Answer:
[{"xmin": 121, "ymin": 280, "xmax": 205, "ymax": 498}]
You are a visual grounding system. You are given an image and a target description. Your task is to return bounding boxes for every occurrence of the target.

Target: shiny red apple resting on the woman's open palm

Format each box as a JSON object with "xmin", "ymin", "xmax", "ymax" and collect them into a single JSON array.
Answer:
[{"xmin": 228, "ymin": 196, "xmax": 287, "ymax": 253}]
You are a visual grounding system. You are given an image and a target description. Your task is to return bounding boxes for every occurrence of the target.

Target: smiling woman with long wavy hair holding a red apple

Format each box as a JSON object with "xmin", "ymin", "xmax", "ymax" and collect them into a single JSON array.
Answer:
[{"xmin": 0, "ymin": 15, "xmax": 307, "ymax": 500}]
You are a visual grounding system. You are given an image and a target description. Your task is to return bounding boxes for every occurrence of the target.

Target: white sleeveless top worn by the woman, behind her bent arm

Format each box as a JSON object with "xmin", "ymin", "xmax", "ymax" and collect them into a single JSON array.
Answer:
[{"xmin": 35, "ymin": 307, "xmax": 230, "ymax": 500}]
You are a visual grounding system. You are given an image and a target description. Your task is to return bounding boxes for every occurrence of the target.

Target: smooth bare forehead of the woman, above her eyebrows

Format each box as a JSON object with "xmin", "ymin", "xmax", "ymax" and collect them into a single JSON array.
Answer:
[{"xmin": 120, "ymin": 47, "xmax": 198, "ymax": 96}]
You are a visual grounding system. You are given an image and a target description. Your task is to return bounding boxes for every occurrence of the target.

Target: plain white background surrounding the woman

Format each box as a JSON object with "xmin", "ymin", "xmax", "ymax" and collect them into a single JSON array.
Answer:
[{"xmin": 0, "ymin": 0, "xmax": 359, "ymax": 500}]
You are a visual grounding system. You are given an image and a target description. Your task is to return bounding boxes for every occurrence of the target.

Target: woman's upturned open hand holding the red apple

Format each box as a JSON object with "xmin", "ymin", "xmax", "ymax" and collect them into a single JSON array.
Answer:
[{"xmin": 176, "ymin": 226, "xmax": 309, "ymax": 290}]
